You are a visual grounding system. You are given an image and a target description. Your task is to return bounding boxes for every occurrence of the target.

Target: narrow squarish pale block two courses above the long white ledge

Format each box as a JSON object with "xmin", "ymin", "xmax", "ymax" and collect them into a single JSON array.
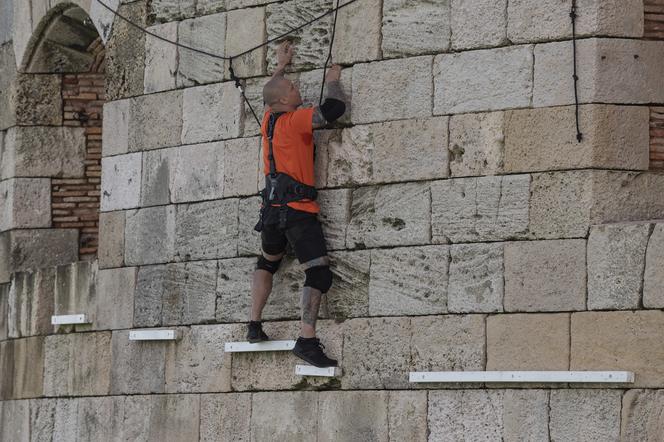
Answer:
[{"xmin": 447, "ymin": 244, "xmax": 504, "ymax": 313}]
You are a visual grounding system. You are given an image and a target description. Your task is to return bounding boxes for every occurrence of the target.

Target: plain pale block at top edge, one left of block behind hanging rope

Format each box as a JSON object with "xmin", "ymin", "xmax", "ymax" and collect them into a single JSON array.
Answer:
[{"xmin": 451, "ymin": 0, "xmax": 508, "ymax": 50}]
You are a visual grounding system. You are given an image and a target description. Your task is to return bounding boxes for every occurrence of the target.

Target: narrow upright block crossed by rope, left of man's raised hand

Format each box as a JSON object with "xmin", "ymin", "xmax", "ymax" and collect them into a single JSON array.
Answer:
[{"xmin": 226, "ymin": 8, "xmax": 267, "ymax": 78}]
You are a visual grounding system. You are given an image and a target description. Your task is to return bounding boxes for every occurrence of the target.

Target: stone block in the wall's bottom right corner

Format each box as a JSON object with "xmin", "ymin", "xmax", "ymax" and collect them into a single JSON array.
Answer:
[{"xmin": 620, "ymin": 390, "xmax": 664, "ymax": 442}]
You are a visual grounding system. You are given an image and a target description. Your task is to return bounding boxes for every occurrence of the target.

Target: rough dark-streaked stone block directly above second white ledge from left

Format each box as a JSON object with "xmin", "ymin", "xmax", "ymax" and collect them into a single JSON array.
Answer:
[{"xmin": 134, "ymin": 261, "xmax": 217, "ymax": 327}]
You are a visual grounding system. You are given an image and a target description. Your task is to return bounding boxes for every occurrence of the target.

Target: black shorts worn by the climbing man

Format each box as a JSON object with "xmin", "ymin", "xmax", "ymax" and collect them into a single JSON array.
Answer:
[{"xmin": 261, "ymin": 207, "xmax": 327, "ymax": 264}]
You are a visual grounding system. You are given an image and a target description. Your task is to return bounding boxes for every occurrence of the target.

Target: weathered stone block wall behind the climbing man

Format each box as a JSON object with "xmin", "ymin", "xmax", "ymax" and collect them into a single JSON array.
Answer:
[{"xmin": 0, "ymin": 0, "xmax": 664, "ymax": 441}]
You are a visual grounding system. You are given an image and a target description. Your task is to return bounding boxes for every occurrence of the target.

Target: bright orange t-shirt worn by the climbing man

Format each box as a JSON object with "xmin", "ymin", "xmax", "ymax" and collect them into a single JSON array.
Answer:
[{"xmin": 261, "ymin": 107, "xmax": 320, "ymax": 213}]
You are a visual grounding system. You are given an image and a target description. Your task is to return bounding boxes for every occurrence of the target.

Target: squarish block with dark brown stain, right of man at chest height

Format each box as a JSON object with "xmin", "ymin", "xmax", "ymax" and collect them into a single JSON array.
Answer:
[{"xmin": 449, "ymin": 112, "xmax": 505, "ymax": 177}]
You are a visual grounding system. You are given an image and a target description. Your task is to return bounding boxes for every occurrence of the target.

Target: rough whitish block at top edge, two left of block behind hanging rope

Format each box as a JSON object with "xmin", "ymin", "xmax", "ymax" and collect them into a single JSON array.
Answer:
[{"xmin": 382, "ymin": 0, "xmax": 451, "ymax": 57}]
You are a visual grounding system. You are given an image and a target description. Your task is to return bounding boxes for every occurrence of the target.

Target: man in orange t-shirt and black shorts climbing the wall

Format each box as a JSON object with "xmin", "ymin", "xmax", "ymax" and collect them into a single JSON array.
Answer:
[{"xmin": 247, "ymin": 42, "xmax": 346, "ymax": 367}]
